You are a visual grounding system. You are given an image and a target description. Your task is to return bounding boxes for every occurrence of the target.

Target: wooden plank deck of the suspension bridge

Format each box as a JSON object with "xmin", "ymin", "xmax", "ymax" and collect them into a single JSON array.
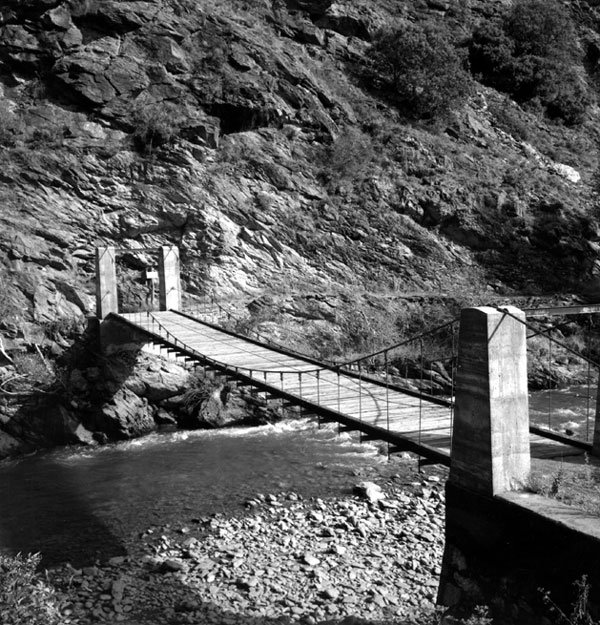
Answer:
[{"xmin": 117, "ymin": 311, "xmax": 582, "ymax": 465}]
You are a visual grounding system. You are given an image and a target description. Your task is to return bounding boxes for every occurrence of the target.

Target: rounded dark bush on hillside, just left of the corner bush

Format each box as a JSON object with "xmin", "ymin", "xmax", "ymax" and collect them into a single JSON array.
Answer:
[{"xmin": 368, "ymin": 23, "xmax": 472, "ymax": 118}]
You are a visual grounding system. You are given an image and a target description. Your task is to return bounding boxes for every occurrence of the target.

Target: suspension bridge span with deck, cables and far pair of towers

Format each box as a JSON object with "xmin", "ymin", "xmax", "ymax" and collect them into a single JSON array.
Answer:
[{"xmin": 97, "ymin": 248, "xmax": 597, "ymax": 466}]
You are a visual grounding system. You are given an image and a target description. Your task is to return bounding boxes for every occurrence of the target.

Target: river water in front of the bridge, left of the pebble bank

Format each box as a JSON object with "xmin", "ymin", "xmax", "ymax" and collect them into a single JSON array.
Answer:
[{"xmin": 0, "ymin": 420, "xmax": 394, "ymax": 564}]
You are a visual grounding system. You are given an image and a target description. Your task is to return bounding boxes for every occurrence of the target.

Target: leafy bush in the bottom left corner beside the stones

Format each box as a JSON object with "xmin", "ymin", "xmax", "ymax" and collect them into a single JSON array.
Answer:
[{"xmin": 0, "ymin": 554, "xmax": 69, "ymax": 625}]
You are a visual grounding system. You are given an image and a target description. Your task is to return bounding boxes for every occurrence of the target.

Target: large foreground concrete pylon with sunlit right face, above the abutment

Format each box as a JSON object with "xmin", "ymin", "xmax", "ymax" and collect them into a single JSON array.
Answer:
[{"xmin": 450, "ymin": 306, "xmax": 530, "ymax": 496}]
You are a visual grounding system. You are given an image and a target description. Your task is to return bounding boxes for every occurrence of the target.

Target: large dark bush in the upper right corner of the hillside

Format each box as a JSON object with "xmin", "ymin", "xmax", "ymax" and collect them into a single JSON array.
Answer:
[{"xmin": 469, "ymin": 0, "xmax": 592, "ymax": 124}]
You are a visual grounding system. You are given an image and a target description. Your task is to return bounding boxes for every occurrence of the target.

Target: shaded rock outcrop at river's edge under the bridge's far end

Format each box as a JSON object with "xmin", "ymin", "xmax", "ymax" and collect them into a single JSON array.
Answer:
[{"xmin": 0, "ymin": 344, "xmax": 290, "ymax": 458}]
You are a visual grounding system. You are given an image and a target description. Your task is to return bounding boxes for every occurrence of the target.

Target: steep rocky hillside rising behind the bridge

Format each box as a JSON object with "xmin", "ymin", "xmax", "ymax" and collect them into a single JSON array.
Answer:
[{"xmin": 0, "ymin": 0, "xmax": 600, "ymax": 350}]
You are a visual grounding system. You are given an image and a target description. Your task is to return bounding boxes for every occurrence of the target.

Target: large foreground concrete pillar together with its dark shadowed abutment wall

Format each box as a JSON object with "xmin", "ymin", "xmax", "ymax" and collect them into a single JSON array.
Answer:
[{"xmin": 438, "ymin": 307, "xmax": 600, "ymax": 625}]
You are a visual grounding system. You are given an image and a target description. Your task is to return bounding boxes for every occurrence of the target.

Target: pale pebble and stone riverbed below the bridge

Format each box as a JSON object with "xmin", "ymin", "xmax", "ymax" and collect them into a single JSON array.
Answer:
[{"xmin": 48, "ymin": 471, "xmax": 444, "ymax": 625}]
